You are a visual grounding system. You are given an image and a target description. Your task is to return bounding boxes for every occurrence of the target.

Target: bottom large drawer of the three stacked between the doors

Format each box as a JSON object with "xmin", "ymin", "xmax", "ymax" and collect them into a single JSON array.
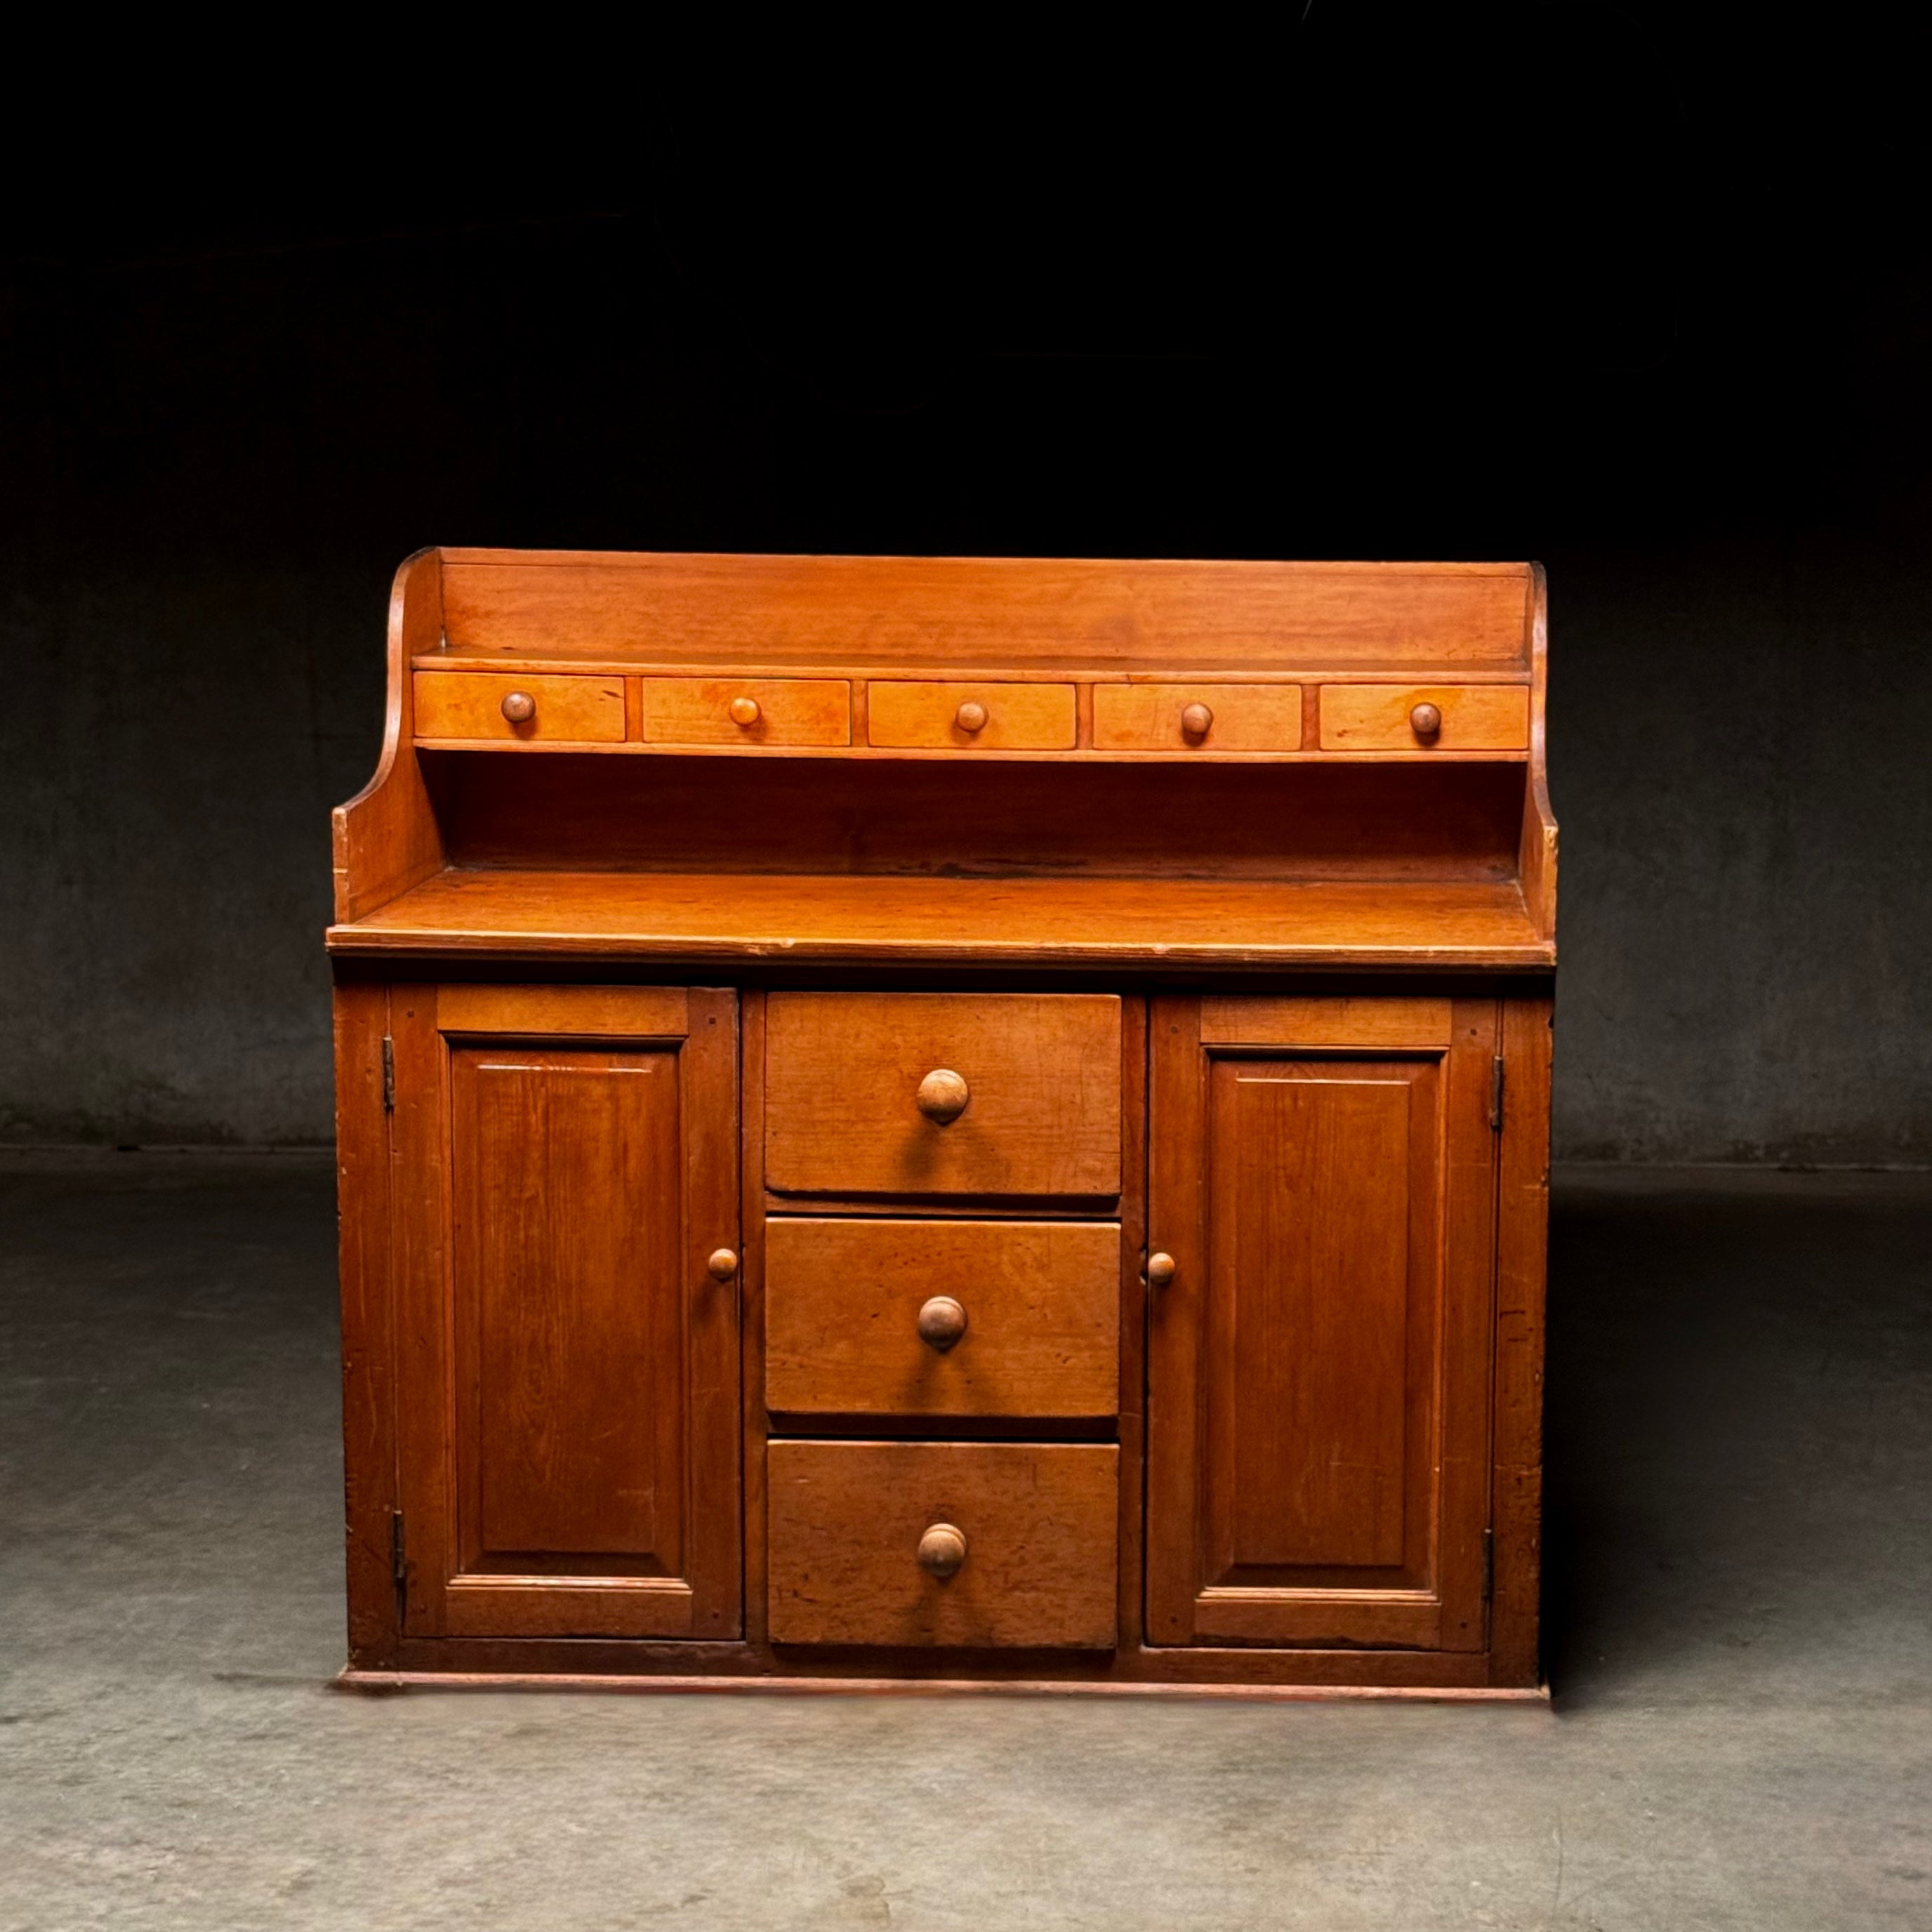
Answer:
[{"xmin": 767, "ymin": 1441, "xmax": 1120, "ymax": 1650}]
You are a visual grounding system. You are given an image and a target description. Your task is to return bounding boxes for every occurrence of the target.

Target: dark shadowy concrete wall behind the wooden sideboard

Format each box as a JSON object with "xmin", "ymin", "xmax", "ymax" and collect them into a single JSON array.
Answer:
[{"xmin": 0, "ymin": 0, "xmax": 1932, "ymax": 1165}]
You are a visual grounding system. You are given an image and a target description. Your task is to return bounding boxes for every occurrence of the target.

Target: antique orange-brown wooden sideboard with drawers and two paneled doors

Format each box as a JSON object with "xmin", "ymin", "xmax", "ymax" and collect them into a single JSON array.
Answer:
[{"xmin": 329, "ymin": 550, "xmax": 1555, "ymax": 1696}]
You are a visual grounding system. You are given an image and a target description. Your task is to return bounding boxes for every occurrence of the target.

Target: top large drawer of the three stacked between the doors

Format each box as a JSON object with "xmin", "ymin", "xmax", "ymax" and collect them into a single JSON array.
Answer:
[{"xmin": 765, "ymin": 993, "xmax": 1120, "ymax": 1200}]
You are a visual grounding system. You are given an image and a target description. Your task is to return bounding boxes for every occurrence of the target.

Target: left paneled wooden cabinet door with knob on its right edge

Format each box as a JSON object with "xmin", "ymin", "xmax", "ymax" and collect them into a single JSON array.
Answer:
[{"xmin": 392, "ymin": 986, "xmax": 742, "ymax": 1639}]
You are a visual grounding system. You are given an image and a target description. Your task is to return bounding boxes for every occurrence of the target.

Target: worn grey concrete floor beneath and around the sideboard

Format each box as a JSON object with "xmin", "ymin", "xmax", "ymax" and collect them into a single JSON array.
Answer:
[{"xmin": 0, "ymin": 1156, "xmax": 1932, "ymax": 1932}]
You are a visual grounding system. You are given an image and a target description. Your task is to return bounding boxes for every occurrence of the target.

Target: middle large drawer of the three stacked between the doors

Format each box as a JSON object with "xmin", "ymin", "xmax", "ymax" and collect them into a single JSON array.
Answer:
[{"xmin": 765, "ymin": 1217, "xmax": 1120, "ymax": 1418}]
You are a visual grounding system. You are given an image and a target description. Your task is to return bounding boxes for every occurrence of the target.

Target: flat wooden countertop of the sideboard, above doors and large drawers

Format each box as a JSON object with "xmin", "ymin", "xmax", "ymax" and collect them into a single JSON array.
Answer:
[{"xmin": 329, "ymin": 869, "xmax": 1555, "ymax": 972}]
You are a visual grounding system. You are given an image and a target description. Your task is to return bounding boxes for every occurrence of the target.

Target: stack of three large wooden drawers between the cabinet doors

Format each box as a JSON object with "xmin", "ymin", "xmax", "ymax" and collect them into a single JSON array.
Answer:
[{"xmin": 765, "ymin": 993, "xmax": 1120, "ymax": 1650}]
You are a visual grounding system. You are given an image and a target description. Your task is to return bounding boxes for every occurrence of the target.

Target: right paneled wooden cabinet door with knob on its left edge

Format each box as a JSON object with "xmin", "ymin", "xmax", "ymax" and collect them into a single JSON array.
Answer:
[{"xmin": 1148, "ymin": 997, "xmax": 1497, "ymax": 1650}]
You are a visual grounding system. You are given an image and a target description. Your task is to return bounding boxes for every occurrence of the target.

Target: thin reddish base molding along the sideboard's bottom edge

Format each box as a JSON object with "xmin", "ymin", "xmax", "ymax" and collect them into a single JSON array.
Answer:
[{"xmin": 332, "ymin": 1669, "xmax": 1549, "ymax": 1708}]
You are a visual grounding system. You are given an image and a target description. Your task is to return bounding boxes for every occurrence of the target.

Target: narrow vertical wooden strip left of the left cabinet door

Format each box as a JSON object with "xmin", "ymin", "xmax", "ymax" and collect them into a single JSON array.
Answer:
[{"xmin": 336, "ymin": 984, "xmax": 396, "ymax": 1669}]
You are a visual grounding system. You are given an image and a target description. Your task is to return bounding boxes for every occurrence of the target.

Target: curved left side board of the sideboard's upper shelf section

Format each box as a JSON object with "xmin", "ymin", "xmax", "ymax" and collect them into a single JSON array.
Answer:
[{"xmin": 331, "ymin": 550, "xmax": 442, "ymax": 922}]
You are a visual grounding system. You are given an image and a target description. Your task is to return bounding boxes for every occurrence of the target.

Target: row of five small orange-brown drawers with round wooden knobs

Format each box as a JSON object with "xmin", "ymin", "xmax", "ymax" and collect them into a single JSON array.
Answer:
[{"xmin": 416, "ymin": 670, "xmax": 1530, "ymax": 752}]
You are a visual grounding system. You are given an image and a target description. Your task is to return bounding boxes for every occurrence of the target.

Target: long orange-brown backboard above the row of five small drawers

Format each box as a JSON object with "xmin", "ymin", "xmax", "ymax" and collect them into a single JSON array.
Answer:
[{"xmin": 430, "ymin": 549, "xmax": 1530, "ymax": 673}]
